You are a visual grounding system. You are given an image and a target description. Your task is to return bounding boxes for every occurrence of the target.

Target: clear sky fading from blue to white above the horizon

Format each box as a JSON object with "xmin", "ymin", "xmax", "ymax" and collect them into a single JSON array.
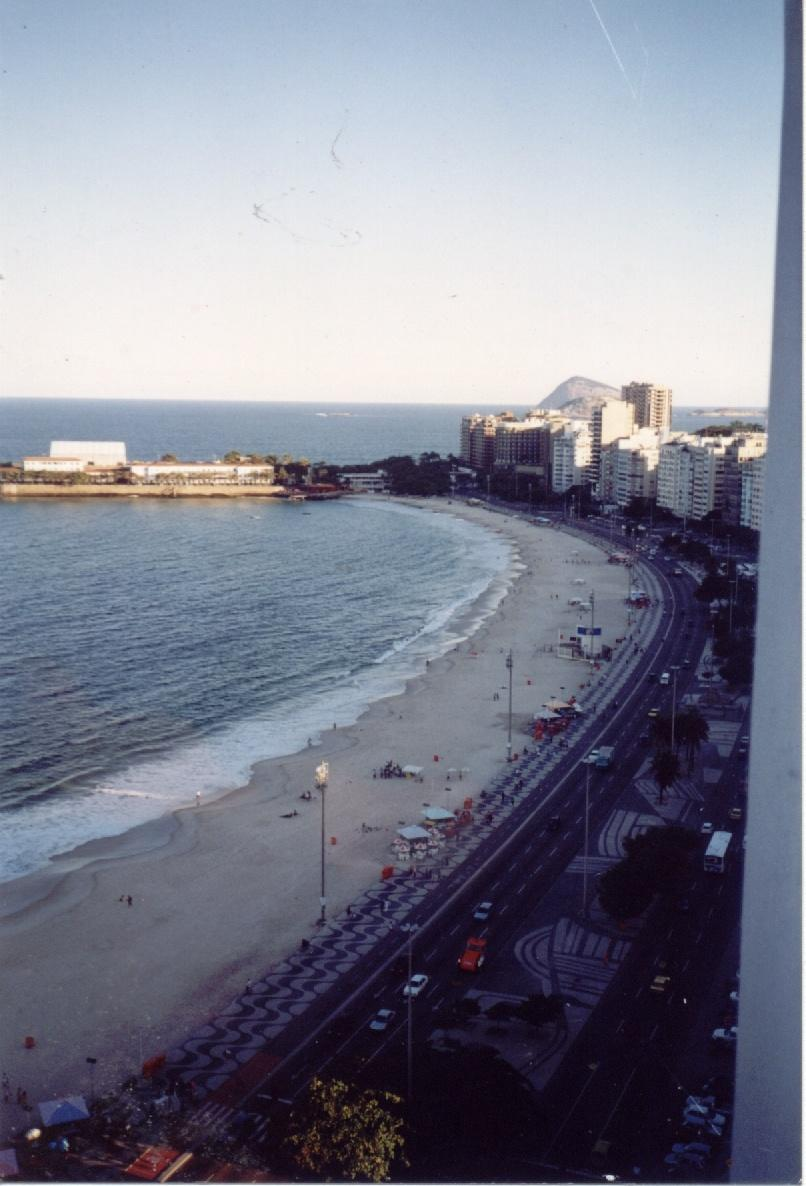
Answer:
[{"xmin": 0, "ymin": 0, "xmax": 783, "ymax": 407}]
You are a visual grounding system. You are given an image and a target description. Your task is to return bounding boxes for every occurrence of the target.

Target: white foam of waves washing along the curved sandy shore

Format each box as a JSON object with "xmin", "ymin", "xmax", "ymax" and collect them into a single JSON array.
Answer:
[{"xmin": 0, "ymin": 504, "xmax": 523, "ymax": 880}]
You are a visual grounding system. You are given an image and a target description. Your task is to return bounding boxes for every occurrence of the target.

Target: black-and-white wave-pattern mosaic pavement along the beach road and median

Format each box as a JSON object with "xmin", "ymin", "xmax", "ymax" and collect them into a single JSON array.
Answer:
[{"xmin": 167, "ymin": 552, "xmax": 663, "ymax": 1100}]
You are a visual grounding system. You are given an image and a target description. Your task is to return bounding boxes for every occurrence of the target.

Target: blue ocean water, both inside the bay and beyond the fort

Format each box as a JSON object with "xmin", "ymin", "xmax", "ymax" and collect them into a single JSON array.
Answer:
[{"xmin": 0, "ymin": 400, "xmax": 768, "ymax": 880}]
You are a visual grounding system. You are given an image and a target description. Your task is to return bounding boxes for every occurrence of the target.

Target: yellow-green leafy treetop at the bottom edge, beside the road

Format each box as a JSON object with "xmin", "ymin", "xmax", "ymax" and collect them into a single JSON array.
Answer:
[{"xmin": 287, "ymin": 1078, "xmax": 404, "ymax": 1182}]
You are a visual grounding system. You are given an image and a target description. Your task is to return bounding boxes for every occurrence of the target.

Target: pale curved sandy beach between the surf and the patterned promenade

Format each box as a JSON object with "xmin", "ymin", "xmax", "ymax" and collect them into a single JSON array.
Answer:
[{"xmin": 0, "ymin": 503, "xmax": 640, "ymax": 1135}]
